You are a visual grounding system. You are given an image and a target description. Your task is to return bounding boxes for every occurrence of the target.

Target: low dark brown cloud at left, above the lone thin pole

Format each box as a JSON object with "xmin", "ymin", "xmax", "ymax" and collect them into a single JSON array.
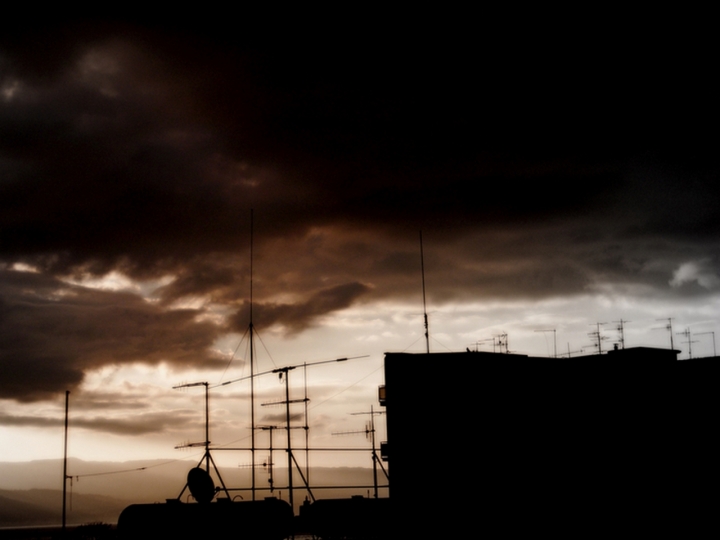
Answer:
[{"xmin": 0, "ymin": 271, "xmax": 224, "ymax": 400}]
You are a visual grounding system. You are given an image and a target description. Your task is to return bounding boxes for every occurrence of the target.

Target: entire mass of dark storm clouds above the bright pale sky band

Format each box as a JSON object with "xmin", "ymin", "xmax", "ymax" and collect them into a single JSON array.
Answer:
[{"xmin": 0, "ymin": 20, "xmax": 720, "ymax": 399}]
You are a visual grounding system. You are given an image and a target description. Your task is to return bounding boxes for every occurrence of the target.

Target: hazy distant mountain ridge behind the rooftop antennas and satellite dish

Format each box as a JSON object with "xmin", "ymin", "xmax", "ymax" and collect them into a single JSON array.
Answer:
[{"xmin": 0, "ymin": 459, "xmax": 387, "ymax": 527}]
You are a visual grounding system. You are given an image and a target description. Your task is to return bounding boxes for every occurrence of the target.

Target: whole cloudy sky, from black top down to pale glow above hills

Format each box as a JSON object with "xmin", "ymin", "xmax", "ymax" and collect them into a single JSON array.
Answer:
[{"xmin": 0, "ymin": 17, "xmax": 720, "ymax": 466}]
